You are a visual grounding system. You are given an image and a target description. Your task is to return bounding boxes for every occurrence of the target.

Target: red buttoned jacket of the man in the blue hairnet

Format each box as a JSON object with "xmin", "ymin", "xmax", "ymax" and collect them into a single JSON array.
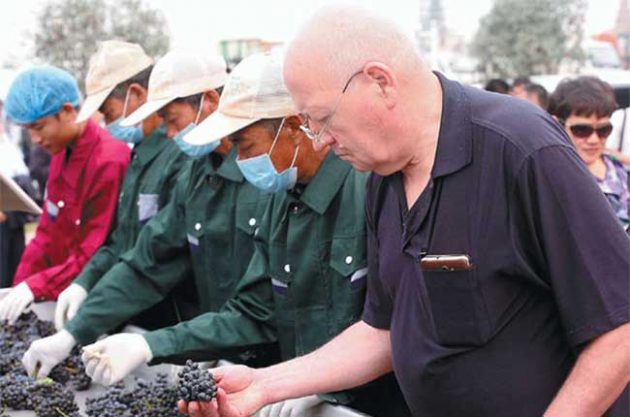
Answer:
[{"xmin": 13, "ymin": 121, "xmax": 131, "ymax": 300}]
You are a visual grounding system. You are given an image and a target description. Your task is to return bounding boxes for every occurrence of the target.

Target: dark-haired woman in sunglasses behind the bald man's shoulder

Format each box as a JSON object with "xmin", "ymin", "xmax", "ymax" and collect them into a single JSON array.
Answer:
[{"xmin": 549, "ymin": 77, "xmax": 630, "ymax": 230}]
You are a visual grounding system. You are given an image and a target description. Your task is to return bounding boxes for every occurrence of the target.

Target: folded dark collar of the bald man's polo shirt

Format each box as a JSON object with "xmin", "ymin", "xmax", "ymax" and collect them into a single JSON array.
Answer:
[{"xmin": 431, "ymin": 72, "xmax": 472, "ymax": 178}]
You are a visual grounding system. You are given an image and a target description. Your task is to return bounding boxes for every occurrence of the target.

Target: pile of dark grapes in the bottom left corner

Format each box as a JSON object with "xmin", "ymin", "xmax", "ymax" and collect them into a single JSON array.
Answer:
[{"xmin": 0, "ymin": 312, "xmax": 91, "ymax": 417}]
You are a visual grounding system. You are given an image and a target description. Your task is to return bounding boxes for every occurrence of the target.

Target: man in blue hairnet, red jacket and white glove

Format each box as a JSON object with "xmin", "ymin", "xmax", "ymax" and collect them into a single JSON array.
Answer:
[{"xmin": 0, "ymin": 66, "xmax": 130, "ymax": 322}]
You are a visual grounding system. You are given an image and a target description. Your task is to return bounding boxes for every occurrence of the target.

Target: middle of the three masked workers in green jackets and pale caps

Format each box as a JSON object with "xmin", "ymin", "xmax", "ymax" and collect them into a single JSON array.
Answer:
[{"xmin": 22, "ymin": 51, "xmax": 270, "ymax": 377}]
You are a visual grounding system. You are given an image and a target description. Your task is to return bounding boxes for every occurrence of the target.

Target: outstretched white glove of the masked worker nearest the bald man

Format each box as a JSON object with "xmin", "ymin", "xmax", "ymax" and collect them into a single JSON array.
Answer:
[{"xmin": 81, "ymin": 333, "xmax": 153, "ymax": 385}]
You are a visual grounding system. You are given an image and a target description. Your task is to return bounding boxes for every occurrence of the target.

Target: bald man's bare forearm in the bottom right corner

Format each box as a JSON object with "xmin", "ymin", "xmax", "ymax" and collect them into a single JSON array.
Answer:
[{"xmin": 545, "ymin": 324, "xmax": 630, "ymax": 417}]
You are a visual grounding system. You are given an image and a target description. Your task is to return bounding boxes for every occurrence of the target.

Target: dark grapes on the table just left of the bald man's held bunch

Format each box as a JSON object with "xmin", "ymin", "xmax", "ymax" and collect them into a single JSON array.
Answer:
[{"xmin": 85, "ymin": 374, "xmax": 182, "ymax": 417}]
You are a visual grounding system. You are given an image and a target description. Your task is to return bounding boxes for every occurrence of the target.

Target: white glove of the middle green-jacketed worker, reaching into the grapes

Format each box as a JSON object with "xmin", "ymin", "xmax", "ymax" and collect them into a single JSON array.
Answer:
[{"xmin": 22, "ymin": 330, "xmax": 77, "ymax": 379}]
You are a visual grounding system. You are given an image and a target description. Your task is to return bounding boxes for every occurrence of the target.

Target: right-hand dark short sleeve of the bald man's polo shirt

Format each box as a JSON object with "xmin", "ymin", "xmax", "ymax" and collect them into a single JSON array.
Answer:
[{"xmin": 510, "ymin": 146, "xmax": 630, "ymax": 347}]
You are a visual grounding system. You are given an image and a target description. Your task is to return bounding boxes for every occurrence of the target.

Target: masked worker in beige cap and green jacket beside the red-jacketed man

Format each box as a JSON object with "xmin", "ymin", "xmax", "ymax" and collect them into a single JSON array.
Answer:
[{"xmin": 50, "ymin": 41, "xmax": 188, "ymax": 330}]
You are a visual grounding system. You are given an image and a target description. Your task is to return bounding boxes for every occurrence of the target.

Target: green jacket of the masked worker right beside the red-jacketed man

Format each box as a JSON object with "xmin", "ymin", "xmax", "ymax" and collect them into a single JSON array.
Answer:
[{"xmin": 74, "ymin": 126, "xmax": 188, "ymax": 292}]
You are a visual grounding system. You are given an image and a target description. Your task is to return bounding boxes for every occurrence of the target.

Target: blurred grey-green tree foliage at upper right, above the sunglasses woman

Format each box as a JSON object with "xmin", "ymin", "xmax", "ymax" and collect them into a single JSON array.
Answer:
[{"xmin": 472, "ymin": 0, "xmax": 587, "ymax": 78}]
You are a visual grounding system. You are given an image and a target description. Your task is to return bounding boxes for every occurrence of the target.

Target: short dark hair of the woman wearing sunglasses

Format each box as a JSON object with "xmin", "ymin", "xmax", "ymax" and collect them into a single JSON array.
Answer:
[{"xmin": 548, "ymin": 76, "xmax": 617, "ymax": 120}]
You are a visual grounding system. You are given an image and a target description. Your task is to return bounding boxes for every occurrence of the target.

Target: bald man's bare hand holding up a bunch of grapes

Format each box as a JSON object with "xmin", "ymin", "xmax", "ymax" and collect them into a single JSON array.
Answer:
[{"xmin": 177, "ymin": 365, "xmax": 265, "ymax": 417}]
